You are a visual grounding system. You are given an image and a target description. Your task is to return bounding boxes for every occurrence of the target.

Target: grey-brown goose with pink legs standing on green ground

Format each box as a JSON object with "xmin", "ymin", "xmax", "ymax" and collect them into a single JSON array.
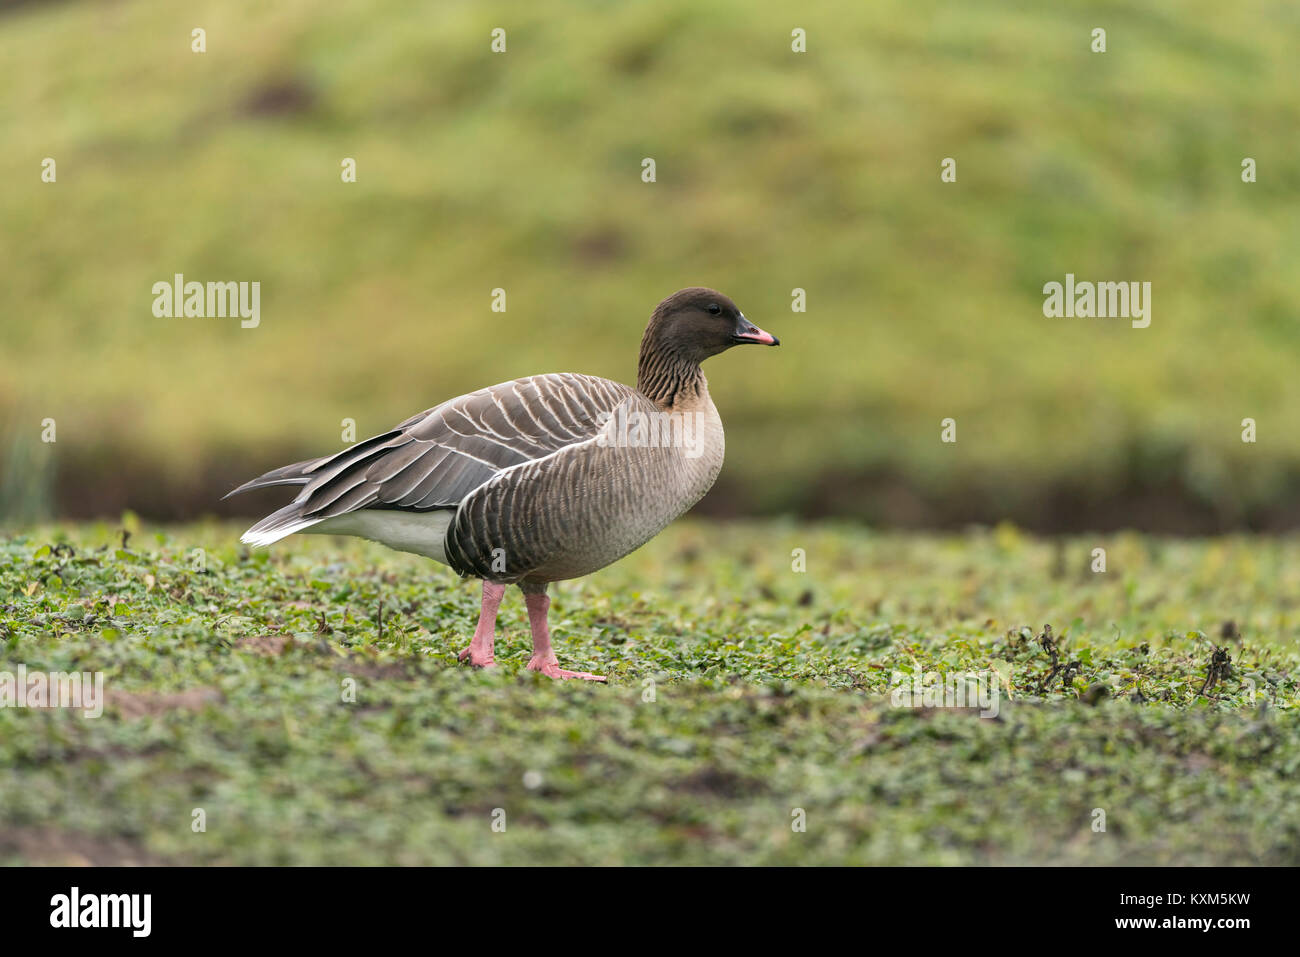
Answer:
[{"xmin": 225, "ymin": 286, "xmax": 780, "ymax": 681}]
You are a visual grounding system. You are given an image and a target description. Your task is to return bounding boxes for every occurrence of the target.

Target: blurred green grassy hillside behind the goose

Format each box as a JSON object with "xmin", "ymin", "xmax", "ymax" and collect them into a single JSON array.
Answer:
[{"xmin": 0, "ymin": 0, "xmax": 1300, "ymax": 529}]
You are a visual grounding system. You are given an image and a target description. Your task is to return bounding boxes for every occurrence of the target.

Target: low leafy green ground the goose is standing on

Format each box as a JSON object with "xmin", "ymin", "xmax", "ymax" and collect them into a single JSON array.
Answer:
[{"xmin": 0, "ymin": 518, "xmax": 1300, "ymax": 865}]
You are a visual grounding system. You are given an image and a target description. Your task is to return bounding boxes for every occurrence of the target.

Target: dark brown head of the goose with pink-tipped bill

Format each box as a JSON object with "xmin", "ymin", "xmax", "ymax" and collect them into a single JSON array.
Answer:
[{"xmin": 641, "ymin": 286, "xmax": 781, "ymax": 363}]
